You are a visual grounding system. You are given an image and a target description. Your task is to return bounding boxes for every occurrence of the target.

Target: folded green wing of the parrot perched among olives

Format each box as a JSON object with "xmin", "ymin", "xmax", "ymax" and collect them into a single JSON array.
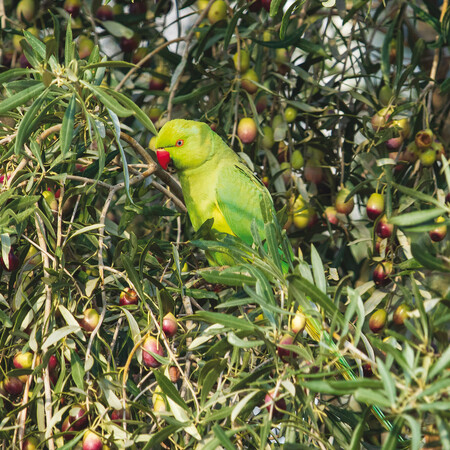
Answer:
[{"xmin": 216, "ymin": 163, "xmax": 270, "ymax": 245}]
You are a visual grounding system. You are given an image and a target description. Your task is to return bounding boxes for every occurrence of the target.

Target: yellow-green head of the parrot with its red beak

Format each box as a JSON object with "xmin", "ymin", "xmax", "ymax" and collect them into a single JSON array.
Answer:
[{"xmin": 156, "ymin": 119, "xmax": 214, "ymax": 170}]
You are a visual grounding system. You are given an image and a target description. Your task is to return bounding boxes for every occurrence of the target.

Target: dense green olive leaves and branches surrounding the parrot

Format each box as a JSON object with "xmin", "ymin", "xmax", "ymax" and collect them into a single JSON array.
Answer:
[{"xmin": 0, "ymin": 0, "xmax": 450, "ymax": 449}]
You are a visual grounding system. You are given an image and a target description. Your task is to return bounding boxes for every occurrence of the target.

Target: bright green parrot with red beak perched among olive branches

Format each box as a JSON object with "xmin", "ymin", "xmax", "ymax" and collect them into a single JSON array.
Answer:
[{"xmin": 156, "ymin": 119, "xmax": 272, "ymax": 250}]
